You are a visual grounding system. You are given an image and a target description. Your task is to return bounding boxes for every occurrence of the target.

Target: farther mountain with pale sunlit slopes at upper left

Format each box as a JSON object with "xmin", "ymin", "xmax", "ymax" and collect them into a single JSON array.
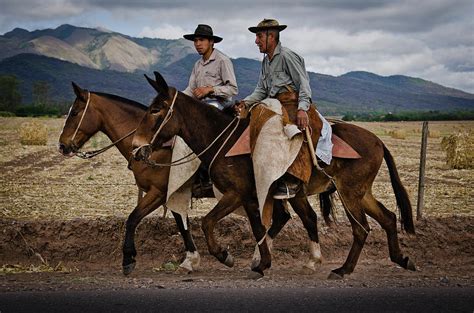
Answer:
[{"xmin": 0, "ymin": 25, "xmax": 194, "ymax": 72}]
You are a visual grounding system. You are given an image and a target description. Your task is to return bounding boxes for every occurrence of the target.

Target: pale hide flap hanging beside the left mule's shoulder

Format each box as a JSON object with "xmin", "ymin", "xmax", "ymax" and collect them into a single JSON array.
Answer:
[{"xmin": 166, "ymin": 136, "xmax": 201, "ymax": 229}]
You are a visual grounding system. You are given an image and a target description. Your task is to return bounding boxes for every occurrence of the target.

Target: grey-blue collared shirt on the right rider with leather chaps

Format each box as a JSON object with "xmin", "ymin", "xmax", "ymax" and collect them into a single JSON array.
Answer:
[{"xmin": 244, "ymin": 42, "xmax": 311, "ymax": 111}]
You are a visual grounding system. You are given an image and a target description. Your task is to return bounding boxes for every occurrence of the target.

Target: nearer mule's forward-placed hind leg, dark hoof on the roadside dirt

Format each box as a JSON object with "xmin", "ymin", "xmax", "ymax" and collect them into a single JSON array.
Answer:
[{"xmin": 328, "ymin": 193, "xmax": 370, "ymax": 279}]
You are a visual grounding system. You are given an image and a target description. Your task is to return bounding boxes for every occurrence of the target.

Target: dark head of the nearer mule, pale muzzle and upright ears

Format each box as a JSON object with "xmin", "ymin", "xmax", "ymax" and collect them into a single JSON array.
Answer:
[{"xmin": 133, "ymin": 72, "xmax": 182, "ymax": 159}]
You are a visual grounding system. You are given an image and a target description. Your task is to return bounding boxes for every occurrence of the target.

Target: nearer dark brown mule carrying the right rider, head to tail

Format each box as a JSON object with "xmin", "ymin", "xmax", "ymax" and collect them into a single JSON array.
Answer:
[{"xmin": 133, "ymin": 72, "xmax": 415, "ymax": 278}]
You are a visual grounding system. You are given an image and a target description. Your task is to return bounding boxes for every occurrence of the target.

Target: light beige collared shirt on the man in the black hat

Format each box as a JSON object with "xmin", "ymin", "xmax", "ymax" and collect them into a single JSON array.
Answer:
[{"xmin": 183, "ymin": 49, "xmax": 238, "ymax": 106}]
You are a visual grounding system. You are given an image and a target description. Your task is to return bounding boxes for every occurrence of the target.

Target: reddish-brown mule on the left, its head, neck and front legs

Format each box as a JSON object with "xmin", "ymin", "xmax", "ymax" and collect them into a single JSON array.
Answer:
[{"xmin": 59, "ymin": 83, "xmax": 199, "ymax": 275}]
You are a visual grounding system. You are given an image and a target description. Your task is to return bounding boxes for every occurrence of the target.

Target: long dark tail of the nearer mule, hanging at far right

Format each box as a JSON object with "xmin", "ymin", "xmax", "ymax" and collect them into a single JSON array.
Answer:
[{"xmin": 383, "ymin": 145, "xmax": 415, "ymax": 234}]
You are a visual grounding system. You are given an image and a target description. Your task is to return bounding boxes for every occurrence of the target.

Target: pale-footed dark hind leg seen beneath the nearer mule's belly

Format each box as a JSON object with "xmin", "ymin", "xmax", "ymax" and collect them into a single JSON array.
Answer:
[{"xmin": 289, "ymin": 194, "xmax": 322, "ymax": 271}]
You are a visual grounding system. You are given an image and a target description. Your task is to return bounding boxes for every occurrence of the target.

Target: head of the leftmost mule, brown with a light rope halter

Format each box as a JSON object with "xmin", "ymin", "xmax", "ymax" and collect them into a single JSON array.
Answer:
[{"xmin": 58, "ymin": 82, "xmax": 100, "ymax": 156}]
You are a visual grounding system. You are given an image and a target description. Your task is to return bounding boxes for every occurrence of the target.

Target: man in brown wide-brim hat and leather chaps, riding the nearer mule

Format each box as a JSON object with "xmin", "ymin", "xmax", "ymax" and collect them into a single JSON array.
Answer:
[{"xmin": 241, "ymin": 19, "xmax": 331, "ymax": 199}]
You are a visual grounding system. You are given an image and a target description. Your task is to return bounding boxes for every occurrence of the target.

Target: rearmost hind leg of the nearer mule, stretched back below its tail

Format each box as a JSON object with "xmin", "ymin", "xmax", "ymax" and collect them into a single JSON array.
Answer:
[{"xmin": 362, "ymin": 192, "xmax": 416, "ymax": 271}]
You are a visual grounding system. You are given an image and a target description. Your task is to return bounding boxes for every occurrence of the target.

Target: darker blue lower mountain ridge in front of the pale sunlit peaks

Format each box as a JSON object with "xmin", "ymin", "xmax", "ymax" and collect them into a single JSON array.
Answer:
[{"xmin": 0, "ymin": 54, "xmax": 474, "ymax": 114}]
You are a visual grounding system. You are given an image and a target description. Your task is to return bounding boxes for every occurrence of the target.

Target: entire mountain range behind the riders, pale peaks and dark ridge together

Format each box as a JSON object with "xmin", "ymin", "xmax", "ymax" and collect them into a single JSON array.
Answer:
[{"xmin": 0, "ymin": 25, "xmax": 474, "ymax": 114}]
